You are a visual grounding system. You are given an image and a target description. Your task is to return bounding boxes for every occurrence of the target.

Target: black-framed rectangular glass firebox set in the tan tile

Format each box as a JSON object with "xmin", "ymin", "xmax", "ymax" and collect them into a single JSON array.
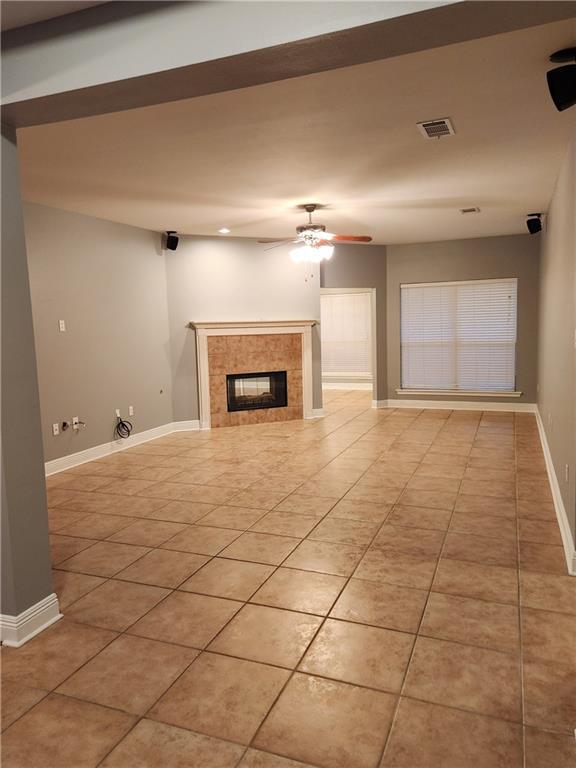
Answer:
[{"xmin": 226, "ymin": 371, "xmax": 288, "ymax": 412}]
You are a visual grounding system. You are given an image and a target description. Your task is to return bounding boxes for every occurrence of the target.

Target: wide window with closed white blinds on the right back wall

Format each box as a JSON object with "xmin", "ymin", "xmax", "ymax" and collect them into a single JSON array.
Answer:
[{"xmin": 400, "ymin": 279, "xmax": 517, "ymax": 392}]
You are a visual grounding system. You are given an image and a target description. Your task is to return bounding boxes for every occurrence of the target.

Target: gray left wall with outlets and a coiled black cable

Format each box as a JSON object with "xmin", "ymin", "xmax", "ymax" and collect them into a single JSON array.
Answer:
[{"xmin": 24, "ymin": 203, "xmax": 172, "ymax": 460}]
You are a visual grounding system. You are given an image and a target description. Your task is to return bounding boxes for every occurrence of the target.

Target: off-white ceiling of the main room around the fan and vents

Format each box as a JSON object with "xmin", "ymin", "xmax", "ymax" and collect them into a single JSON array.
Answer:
[{"xmin": 19, "ymin": 20, "xmax": 576, "ymax": 244}]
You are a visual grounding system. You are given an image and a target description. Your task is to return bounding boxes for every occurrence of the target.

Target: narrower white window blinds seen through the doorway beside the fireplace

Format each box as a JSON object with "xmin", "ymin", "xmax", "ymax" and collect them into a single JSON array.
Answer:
[{"xmin": 320, "ymin": 293, "xmax": 372, "ymax": 379}]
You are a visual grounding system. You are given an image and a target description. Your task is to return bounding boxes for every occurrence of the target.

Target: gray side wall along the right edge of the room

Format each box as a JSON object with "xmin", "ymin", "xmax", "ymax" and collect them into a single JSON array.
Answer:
[{"xmin": 538, "ymin": 138, "xmax": 576, "ymax": 539}]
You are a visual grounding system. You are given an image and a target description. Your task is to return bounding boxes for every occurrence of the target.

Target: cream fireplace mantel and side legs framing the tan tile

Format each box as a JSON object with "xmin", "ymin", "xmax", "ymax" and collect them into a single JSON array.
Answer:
[{"xmin": 189, "ymin": 320, "xmax": 318, "ymax": 429}]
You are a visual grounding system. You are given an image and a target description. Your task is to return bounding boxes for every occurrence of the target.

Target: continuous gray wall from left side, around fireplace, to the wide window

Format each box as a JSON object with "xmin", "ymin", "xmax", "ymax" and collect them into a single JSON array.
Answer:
[{"xmin": 25, "ymin": 204, "xmax": 538, "ymax": 468}]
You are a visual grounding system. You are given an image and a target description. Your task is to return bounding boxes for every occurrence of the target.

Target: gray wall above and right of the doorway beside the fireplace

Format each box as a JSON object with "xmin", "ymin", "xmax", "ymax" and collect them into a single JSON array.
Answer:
[{"xmin": 321, "ymin": 245, "xmax": 388, "ymax": 400}]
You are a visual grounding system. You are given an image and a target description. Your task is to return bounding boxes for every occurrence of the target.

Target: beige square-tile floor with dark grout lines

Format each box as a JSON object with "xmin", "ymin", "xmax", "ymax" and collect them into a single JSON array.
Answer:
[{"xmin": 2, "ymin": 391, "xmax": 576, "ymax": 768}]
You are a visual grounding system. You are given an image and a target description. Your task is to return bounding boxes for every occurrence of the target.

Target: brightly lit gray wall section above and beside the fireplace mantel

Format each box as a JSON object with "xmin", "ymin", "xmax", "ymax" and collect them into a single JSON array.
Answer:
[{"xmin": 166, "ymin": 236, "xmax": 322, "ymax": 421}]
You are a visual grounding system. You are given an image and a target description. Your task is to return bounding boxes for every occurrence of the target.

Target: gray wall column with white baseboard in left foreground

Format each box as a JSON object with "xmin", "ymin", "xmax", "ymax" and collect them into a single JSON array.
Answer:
[{"xmin": 0, "ymin": 126, "xmax": 60, "ymax": 646}]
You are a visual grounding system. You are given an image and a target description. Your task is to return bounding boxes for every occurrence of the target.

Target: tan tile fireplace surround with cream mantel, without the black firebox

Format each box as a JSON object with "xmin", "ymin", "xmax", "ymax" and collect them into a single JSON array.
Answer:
[{"xmin": 190, "ymin": 320, "xmax": 316, "ymax": 429}]
